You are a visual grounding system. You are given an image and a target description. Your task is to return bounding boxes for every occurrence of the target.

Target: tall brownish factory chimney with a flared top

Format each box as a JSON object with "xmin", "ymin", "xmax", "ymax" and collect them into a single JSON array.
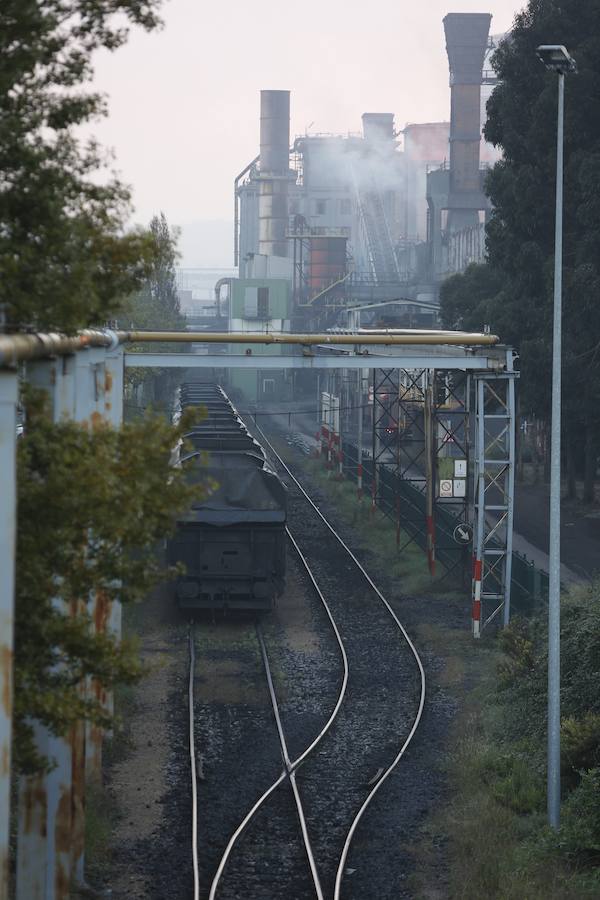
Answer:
[{"xmin": 444, "ymin": 13, "xmax": 492, "ymax": 231}]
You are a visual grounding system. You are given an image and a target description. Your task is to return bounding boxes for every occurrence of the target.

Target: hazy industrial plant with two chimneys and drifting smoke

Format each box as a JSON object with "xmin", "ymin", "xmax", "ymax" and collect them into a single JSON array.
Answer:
[{"xmin": 193, "ymin": 13, "xmax": 502, "ymax": 401}]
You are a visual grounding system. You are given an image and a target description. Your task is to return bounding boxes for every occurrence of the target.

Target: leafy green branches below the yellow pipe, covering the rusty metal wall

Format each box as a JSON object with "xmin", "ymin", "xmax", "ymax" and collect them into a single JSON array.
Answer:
[{"xmin": 14, "ymin": 394, "xmax": 206, "ymax": 772}]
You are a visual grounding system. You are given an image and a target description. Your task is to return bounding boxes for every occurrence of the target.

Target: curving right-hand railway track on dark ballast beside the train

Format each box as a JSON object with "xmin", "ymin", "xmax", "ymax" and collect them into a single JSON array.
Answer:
[{"xmin": 193, "ymin": 428, "xmax": 425, "ymax": 900}]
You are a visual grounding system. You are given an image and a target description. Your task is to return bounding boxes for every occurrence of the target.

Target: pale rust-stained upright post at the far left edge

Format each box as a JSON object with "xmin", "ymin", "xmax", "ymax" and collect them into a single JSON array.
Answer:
[{"xmin": 0, "ymin": 370, "xmax": 18, "ymax": 900}]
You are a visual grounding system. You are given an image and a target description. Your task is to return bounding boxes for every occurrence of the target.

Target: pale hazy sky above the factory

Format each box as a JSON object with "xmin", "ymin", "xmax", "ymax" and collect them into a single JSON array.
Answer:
[{"xmin": 92, "ymin": 0, "xmax": 524, "ymax": 244}]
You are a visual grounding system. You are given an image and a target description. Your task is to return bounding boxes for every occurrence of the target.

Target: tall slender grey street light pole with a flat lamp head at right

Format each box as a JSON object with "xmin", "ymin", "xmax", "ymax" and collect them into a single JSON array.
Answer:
[{"xmin": 537, "ymin": 45, "xmax": 577, "ymax": 828}]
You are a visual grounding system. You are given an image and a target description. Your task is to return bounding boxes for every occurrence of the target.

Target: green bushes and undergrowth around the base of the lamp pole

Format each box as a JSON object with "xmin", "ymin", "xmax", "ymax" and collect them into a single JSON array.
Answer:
[{"xmin": 423, "ymin": 584, "xmax": 600, "ymax": 900}]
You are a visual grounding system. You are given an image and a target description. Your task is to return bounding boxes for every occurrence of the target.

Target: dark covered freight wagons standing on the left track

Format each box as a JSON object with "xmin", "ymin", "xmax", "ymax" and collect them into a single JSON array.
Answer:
[{"xmin": 167, "ymin": 382, "xmax": 286, "ymax": 610}]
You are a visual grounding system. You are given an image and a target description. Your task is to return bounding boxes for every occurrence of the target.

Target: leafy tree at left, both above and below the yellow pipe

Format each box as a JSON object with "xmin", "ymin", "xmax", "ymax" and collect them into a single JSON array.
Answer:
[{"xmin": 0, "ymin": 0, "xmax": 206, "ymax": 772}]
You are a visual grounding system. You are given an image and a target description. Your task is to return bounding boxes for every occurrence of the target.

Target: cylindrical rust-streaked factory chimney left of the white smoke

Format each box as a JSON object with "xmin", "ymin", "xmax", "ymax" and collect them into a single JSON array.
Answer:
[{"xmin": 258, "ymin": 91, "xmax": 290, "ymax": 256}]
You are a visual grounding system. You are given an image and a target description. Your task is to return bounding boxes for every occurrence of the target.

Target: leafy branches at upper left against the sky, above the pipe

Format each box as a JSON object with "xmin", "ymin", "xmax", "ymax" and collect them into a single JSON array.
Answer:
[{"xmin": 0, "ymin": 0, "xmax": 160, "ymax": 331}]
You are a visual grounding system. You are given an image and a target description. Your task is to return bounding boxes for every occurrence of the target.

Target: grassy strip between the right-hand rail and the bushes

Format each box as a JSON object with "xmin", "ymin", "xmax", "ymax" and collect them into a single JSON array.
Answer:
[{"xmin": 410, "ymin": 624, "xmax": 600, "ymax": 900}]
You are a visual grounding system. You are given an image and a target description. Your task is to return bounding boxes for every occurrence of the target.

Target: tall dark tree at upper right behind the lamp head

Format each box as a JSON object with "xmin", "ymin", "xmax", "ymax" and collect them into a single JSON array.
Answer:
[{"xmin": 447, "ymin": 0, "xmax": 600, "ymax": 499}]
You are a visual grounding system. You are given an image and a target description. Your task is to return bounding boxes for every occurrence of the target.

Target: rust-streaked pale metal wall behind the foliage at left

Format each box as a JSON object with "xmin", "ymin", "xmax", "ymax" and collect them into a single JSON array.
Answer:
[{"xmin": 13, "ymin": 346, "xmax": 123, "ymax": 900}]
